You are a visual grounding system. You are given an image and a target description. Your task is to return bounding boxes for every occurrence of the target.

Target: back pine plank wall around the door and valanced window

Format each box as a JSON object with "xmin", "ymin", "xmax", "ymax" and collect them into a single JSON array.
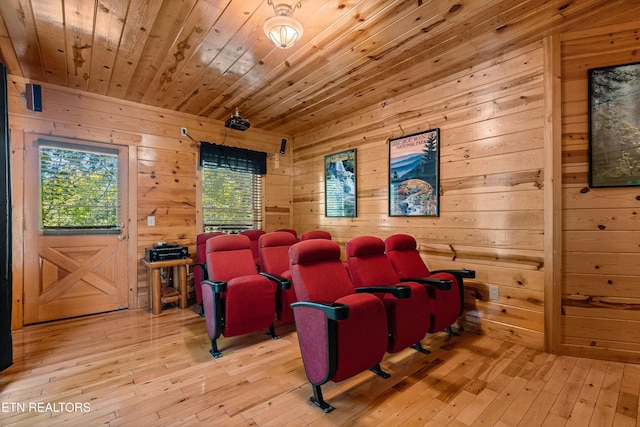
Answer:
[{"xmin": 4, "ymin": 76, "xmax": 292, "ymax": 328}]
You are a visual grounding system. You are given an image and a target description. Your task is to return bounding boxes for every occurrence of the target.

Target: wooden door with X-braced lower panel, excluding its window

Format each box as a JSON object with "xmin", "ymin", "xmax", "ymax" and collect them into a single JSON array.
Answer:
[{"xmin": 24, "ymin": 135, "xmax": 128, "ymax": 324}]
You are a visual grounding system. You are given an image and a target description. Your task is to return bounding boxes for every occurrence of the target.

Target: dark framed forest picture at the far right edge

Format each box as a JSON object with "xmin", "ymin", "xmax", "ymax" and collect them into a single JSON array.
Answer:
[{"xmin": 589, "ymin": 62, "xmax": 640, "ymax": 187}]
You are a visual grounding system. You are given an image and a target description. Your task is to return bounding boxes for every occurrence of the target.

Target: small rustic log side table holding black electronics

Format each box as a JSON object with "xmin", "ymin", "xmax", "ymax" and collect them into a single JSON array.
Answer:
[{"xmin": 142, "ymin": 258, "xmax": 193, "ymax": 314}]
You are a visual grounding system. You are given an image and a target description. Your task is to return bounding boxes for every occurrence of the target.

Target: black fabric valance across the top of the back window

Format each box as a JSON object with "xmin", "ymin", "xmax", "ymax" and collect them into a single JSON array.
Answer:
[{"xmin": 200, "ymin": 141, "xmax": 267, "ymax": 175}]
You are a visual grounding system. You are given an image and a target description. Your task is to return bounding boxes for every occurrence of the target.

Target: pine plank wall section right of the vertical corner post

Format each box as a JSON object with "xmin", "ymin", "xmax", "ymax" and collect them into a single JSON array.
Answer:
[{"xmin": 561, "ymin": 22, "xmax": 640, "ymax": 363}]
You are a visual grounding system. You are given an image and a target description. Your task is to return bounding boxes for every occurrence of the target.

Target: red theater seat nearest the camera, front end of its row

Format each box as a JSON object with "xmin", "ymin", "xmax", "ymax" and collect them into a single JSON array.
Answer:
[{"xmin": 289, "ymin": 240, "xmax": 389, "ymax": 412}]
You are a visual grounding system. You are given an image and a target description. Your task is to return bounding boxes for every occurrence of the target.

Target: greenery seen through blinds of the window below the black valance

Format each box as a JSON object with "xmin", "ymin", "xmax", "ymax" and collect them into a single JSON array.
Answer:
[{"xmin": 202, "ymin": 165, "xmax": 262, "ymax": 233}]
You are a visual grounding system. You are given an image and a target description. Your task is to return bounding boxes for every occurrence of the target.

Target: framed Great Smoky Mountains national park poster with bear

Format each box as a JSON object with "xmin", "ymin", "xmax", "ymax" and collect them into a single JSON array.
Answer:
[{"xmin": 389, "ymin": 129, "xmax": 440, "ymax": 216}]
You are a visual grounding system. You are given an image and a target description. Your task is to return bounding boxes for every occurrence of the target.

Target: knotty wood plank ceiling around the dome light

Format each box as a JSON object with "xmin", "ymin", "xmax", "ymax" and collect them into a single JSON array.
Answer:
[{"xmin": 0, "ymin": 0, "xmax": 640, "ymax": 135}]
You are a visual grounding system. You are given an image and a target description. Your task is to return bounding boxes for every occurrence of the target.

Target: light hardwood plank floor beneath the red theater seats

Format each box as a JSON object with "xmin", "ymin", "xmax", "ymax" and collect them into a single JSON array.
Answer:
[{"xmin": 0, "ymin": 308, "xmax": 640, "ymax": 427}]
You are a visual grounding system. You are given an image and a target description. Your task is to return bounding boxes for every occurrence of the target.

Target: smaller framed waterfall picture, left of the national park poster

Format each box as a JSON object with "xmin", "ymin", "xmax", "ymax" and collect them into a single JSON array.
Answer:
[{"xmin": 324, "ymin": 148, "xmax": 356, "ymax": 217}]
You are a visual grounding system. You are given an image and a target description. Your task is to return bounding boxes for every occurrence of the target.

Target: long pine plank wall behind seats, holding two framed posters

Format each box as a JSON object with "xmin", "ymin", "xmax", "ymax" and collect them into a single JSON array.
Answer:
[{"xmin": 293, "ymin": 42, "xmax": 544, "ymax": 349}]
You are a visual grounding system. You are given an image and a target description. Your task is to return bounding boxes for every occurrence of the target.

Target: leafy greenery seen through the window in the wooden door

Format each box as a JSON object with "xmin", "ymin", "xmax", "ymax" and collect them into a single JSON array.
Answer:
[{"xmin": 39, "ymin": 141, "xmax": 119, "ymax": 231}]
